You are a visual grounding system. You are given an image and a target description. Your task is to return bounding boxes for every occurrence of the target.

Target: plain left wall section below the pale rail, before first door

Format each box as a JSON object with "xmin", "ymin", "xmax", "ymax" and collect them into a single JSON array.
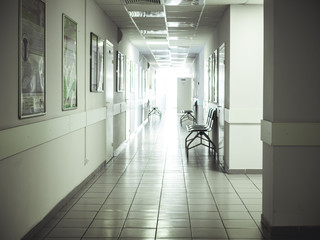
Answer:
[{"xmin": 0, "ymin": 121, "xmax": 105, "ymax": 240}]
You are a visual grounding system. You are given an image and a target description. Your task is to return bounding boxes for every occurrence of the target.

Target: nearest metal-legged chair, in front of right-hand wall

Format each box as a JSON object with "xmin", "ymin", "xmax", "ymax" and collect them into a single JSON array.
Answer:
[{"xmin": 185, "ymin": 108, "xmax": 217, "ymax": 157}]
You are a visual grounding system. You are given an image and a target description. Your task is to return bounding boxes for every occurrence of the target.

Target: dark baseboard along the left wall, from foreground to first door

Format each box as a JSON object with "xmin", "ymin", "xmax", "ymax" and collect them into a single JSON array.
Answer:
[{"xmin": 21, "ymin": 159, "xmax": 112, "ymax": 240}]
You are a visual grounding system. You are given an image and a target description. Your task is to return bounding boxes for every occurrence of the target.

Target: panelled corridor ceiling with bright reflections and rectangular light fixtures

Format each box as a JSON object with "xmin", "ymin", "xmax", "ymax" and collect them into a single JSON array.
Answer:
[{"xmin": 96, "ymin": 0, "xmax": 263, "ymax": 67}]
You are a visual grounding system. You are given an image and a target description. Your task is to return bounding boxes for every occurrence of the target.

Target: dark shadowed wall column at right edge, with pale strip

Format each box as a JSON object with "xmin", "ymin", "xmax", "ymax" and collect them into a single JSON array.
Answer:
[{"xmin": 261, "ymin": 0, "xmax": 320, "ymax": 236}]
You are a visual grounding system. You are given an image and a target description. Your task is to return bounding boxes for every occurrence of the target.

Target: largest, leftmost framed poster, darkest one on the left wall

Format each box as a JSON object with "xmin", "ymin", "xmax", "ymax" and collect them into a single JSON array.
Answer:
[{"xmin": 19, "ymin": 0, "xmax": 46, "ymax": 118}]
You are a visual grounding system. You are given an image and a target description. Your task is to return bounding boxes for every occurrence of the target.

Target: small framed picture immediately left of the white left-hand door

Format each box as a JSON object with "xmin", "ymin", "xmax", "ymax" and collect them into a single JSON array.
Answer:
[{"xmin": 90, "ymin": 33, "xmax": 105, "ymax": 92}]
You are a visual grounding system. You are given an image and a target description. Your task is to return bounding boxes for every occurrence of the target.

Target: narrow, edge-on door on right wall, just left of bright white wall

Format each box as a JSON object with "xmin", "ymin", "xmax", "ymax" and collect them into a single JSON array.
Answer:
[{"xmin": 218, "ymin": 43, "xmax": 226, "ymax": 168}]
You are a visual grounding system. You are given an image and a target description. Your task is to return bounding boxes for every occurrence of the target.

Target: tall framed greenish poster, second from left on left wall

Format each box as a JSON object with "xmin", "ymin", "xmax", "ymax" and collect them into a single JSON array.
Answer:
[{"xmin": 62, "ymin": 14, "xmax": 78, "ymax": 110}]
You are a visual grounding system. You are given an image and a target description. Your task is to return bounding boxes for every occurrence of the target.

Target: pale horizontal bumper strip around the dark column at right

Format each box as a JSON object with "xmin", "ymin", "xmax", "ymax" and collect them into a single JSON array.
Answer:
[{"xmin": 261, "ymin": 120, "xmax": 320, "ymax": 146}]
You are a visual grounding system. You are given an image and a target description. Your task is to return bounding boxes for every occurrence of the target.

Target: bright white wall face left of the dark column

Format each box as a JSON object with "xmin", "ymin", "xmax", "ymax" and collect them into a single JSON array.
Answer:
[{"xmin": 225, "ymin": 5, "xmax": 263, "ymax": 171}]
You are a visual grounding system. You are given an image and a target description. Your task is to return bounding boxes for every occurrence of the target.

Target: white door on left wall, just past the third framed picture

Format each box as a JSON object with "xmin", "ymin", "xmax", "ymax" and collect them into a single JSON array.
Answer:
[{"xmin": 106, "ymin": 40, "xmax": 114, "ymax": 161}]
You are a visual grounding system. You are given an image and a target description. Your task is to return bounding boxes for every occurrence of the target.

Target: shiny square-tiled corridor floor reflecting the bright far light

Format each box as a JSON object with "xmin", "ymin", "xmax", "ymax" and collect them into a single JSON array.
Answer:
[{"xmin": 36, "ymin": 111, "xmax": 263, "ymax": 240}]
